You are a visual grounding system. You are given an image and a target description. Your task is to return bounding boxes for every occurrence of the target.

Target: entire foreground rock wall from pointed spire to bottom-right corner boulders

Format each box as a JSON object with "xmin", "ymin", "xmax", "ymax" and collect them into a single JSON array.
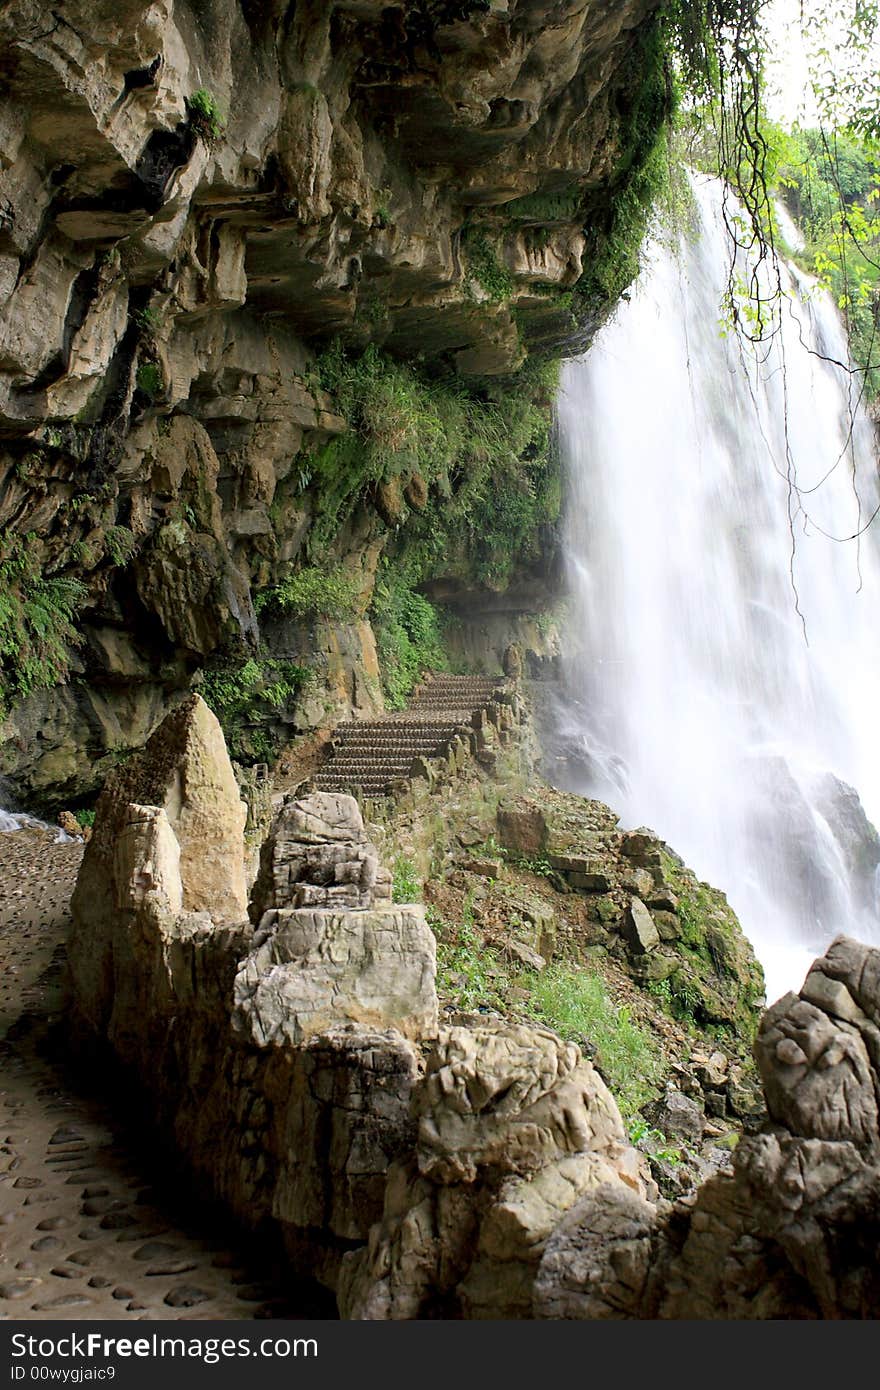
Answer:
[{"xmin": 70, "ymin": 701, "xmax": 880, "ymax": 1319}]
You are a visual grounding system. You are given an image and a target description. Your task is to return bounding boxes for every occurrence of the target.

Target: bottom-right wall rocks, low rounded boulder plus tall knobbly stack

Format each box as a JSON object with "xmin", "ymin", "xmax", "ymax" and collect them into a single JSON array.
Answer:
[{"xmin": 525, "ymin": 937, "xmax": 880, "ymax": 1319}]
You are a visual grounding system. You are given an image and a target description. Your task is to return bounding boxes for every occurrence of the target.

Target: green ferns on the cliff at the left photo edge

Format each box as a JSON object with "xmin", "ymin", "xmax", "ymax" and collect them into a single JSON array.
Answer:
[{"xmin": 0, "ymin": 532, "xmax": 88, "ymax": 710}]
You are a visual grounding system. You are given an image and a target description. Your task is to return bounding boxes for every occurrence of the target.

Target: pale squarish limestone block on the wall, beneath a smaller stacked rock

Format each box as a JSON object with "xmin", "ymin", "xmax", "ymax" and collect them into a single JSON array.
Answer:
[{"xmin": 235, "ymin": 906, "xmax": 437, "ymax": 1047}]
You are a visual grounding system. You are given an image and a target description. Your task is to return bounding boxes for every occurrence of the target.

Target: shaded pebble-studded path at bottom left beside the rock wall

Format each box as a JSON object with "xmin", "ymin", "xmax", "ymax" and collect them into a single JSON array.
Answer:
[{"xmin": 0, "ymin": 830, "xmax": 315, "ymax": 1321}]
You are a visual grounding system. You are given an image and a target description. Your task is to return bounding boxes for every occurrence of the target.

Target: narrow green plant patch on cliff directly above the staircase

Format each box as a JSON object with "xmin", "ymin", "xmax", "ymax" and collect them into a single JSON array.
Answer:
[{"xmin": 370, "ymin": 564, "xmax": 449, "ymax": 709}]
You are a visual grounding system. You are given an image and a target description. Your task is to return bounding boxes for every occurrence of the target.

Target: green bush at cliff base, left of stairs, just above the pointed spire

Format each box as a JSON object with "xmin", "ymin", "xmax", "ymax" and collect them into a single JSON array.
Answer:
[{"xmin": 199, "ymin": 656, "xmax": 311, "ymax": 763}]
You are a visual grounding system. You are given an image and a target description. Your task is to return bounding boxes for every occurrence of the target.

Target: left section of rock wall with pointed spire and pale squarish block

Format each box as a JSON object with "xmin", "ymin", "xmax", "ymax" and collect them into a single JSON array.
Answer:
[{"xmin": 70, "ymin": 702, "xmax": 437, "ymax": 1279}]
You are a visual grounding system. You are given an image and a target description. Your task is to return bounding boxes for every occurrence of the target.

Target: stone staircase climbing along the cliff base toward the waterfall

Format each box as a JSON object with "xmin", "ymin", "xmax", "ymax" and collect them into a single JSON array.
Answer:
[{"xmin": 309, "ymin": 674, "xmax": 510, "ymax": 799}]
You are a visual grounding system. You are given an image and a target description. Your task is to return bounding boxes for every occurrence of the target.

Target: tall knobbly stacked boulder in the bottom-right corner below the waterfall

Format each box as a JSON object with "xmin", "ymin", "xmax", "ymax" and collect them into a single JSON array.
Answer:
[{"xmin": 642, "ymin": 937, "xmax": 880, "ymax": 1318}]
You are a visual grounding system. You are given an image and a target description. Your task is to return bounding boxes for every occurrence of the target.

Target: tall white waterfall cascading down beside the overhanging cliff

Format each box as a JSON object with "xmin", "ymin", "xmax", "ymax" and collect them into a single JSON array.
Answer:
[{"xmin": 559, "ymin": 173, "xmax": 880, "ymax": 999}]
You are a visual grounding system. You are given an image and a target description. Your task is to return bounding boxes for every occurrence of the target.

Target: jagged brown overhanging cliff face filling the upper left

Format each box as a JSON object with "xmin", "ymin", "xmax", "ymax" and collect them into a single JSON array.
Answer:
[{"xmin": 0, "ymin": 0, "xmax": 667, "ymax": 805}]
